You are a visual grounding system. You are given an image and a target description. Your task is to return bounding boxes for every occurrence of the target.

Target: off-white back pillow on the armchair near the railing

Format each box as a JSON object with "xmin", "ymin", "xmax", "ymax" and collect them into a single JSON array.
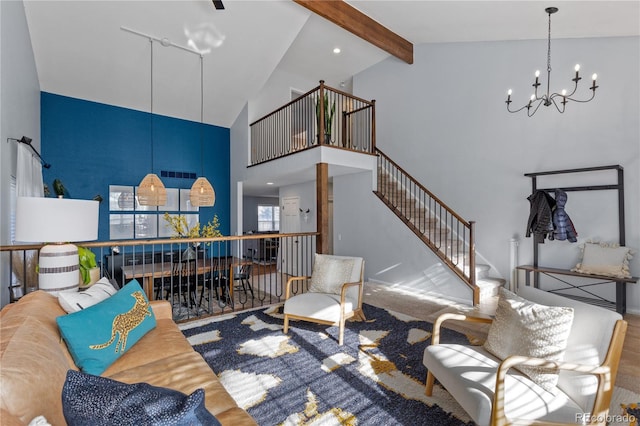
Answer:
[{"xmin": 309, "ymin": 253, "xmax": 355, "ymax": 294}]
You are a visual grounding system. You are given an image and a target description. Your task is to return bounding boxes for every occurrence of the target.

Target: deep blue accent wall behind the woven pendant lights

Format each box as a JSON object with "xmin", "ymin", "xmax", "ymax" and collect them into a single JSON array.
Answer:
[{"xmin": 40, "ymin": 92, "xmax": 231, "ymax": 241}]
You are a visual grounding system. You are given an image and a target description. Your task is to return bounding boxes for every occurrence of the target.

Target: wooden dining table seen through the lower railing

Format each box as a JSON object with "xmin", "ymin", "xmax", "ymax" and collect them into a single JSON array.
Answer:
[{"xmin": 122, "ymin": 256, "xmax": 251, "ymax": 300}]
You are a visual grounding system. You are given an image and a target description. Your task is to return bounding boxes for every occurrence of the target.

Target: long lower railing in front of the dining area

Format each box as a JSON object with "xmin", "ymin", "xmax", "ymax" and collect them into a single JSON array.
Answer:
[{"xmin": 0, "ymin": 233, "xmax": 317, "ymax": 321}]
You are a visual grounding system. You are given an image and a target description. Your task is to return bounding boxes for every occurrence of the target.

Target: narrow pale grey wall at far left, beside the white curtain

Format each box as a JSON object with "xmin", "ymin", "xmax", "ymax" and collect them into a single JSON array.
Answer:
[{"xmin": 0, "ymin": 1, "xmax": 40, "ymax": 306}]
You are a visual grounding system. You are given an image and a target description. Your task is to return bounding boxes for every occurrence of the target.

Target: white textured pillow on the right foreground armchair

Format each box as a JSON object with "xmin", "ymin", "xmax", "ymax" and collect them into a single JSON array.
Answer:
[{"xmin": 484, "ymin": 288, "xmax": 573, "ymax": 393}]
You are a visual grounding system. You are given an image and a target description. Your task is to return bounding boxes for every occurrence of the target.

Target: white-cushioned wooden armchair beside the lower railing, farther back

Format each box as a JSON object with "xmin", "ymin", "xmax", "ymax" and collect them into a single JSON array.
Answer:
[{"xmin": 284, "ymin": 254, "xmax": 365, "ymax": 345}]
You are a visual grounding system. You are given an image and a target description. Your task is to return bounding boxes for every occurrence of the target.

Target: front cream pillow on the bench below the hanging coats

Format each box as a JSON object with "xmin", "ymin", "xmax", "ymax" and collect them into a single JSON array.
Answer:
[{"xmin": 572, "ymin": 242, "xmax": 632, "ymax": 278}]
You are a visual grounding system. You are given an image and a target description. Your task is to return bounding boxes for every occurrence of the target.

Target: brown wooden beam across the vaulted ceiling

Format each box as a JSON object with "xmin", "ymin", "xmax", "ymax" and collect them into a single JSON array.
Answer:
[{"xmin": 293, "ymin": 0, "xmax": 413, "ymax": 64}]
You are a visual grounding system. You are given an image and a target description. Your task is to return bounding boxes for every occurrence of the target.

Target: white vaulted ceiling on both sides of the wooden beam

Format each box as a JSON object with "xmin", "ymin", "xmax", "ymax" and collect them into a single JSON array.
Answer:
[{"xmin": 24, "ymin": 0, "xmax": 640, "ymax": 127}]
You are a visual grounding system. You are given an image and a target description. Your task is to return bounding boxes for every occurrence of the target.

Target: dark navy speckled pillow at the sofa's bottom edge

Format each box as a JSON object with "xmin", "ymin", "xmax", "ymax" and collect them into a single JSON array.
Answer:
[{"xmin": 62, "ymin": 370, "xmax": 220, "ymax": 426}]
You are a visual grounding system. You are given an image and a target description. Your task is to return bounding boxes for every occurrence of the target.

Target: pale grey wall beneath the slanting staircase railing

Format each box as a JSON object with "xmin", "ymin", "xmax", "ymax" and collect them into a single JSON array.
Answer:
[{"xmin": 333, "ymin": 172, "xmax": 472, "ymax": 303}]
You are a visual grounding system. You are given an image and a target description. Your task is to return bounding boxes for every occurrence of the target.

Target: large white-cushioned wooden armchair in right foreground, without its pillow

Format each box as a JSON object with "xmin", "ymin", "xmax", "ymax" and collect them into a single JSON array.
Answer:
[{"xmin": 423, "ymin": 287, "xmax": 627, "ymax": 426}]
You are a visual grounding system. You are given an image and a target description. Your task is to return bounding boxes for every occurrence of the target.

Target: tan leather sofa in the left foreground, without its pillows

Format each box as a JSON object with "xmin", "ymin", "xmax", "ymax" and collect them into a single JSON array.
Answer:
[{"xmin": 0, "ymin": 291, "xmax": 256, "ymax": 426}]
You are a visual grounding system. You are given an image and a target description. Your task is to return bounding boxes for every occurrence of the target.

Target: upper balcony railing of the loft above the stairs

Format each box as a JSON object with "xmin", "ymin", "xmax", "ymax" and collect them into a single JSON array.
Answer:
[{"xmin": 251, "ymin": 81, "xmax": 375, "ymax": 165}]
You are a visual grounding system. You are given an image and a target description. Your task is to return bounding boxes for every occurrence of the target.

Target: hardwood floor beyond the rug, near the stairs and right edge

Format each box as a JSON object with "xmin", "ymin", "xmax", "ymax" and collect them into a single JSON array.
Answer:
[{"xmin": 364, "ymin": 283, "xmax": 640, "ymax": 394}]
